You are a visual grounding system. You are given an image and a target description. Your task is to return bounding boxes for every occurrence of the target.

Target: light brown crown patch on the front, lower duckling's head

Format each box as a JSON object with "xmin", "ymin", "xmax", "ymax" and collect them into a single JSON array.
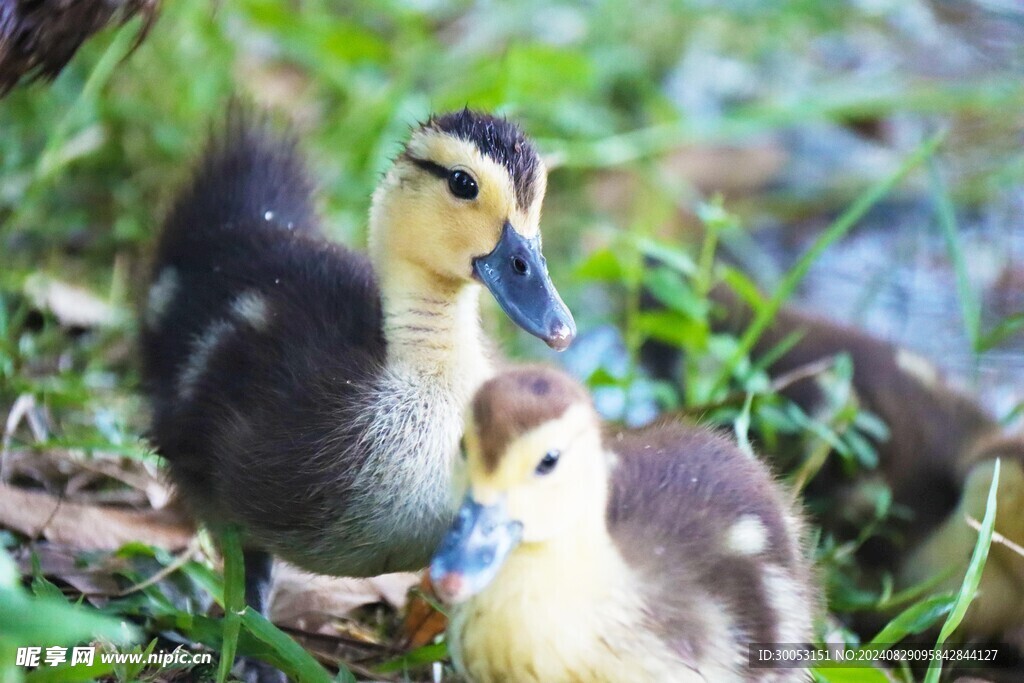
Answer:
[{"xmin": 473, "ymin": 366, "xmax": 592, "ymax": 471}]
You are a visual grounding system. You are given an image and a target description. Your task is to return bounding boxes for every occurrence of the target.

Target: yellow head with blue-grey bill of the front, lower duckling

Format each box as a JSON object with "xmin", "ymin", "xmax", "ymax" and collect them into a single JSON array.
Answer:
[{"xmin": 430, "ymin": 367, "xmax": 607, "ymax": 603}]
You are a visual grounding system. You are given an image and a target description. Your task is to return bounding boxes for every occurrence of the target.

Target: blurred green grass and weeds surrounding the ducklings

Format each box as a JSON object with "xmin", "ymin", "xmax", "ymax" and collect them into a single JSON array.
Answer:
[{"xmin": 0, "ymin": 0, "xmax": 1024, "ymax": 683}]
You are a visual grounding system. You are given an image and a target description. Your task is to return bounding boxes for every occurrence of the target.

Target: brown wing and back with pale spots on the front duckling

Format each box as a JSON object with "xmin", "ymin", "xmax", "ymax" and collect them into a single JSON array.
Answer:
[{"xmin": 607, "ymin": 424, "xmax": 813, "ymax": 673}]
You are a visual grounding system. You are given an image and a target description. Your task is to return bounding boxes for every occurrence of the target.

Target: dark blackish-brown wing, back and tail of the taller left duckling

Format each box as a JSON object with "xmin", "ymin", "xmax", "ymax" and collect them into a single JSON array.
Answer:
[{"xmin": 141, "ymin": 113, "xmax": 385, "ymax": 569}]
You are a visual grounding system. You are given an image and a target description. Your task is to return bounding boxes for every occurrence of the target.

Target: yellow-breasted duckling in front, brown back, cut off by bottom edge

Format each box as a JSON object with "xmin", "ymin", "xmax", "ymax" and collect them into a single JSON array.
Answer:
[{"xmin": 429, "ymin": 367, "xmax": 817, "ymax": 683}]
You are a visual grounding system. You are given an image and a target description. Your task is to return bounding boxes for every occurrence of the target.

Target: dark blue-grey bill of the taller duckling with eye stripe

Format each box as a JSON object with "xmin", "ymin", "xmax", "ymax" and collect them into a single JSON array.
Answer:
[{"xmin": 473, "ymin": 222, "xmax": 575, "ymax": 351}]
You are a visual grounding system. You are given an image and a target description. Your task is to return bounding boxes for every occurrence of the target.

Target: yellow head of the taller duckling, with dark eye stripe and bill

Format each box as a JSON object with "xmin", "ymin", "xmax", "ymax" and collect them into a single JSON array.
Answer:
[{"xmin": 370, "ymin": 109, "xmax": 575, "ymax": 350}]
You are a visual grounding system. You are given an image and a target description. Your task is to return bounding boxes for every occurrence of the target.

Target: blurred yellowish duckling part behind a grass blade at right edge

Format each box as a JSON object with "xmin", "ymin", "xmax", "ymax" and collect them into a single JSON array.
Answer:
[{"xmin": 901, "ymin": 436, "xmax": 1024, "ymax": 640}]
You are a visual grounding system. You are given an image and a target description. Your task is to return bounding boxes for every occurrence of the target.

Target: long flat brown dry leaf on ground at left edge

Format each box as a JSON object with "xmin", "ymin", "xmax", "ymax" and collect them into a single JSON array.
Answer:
[{"xmin": 0, "ymin": 484, "xmax": 196, "ymax": 550}]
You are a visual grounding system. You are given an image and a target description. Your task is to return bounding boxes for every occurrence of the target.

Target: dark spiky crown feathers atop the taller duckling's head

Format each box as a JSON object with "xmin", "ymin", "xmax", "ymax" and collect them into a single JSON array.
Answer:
[{"xmin": 423, "ymin": 109, "xmax": 541, "ymax": 209}]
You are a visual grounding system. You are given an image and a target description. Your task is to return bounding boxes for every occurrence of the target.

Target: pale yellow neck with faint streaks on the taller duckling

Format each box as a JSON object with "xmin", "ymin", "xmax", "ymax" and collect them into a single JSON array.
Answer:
[{"xmin": 381, "ymin": 268, "xmax": 490, "ymax": 390}]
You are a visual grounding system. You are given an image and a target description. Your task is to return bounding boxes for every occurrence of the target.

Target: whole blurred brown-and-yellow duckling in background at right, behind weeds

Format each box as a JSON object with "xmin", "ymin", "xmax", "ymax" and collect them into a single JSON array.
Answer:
[{"xmin": 696, "ymin": 288, "xmax": 1024, "ymax": 651}]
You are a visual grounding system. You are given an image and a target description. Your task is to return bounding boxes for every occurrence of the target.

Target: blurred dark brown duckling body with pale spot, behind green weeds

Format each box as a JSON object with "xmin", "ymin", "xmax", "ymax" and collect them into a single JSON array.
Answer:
[{"xmin": 684, "ymin": 287, "xmax": 998, "ymax": 573}]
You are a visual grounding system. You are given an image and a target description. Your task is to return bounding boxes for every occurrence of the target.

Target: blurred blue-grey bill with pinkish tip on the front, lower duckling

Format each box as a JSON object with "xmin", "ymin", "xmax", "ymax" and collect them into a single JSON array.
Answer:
[{"xmin": 430, "ymin": 495, "xmax": 522, "ymax": 604}]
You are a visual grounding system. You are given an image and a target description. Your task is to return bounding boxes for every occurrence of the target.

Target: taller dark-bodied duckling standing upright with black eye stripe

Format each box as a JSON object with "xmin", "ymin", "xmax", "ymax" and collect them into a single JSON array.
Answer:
[{"xmin": 141, "ymin": 105, "xmax": 575, "ymax": 606}]
